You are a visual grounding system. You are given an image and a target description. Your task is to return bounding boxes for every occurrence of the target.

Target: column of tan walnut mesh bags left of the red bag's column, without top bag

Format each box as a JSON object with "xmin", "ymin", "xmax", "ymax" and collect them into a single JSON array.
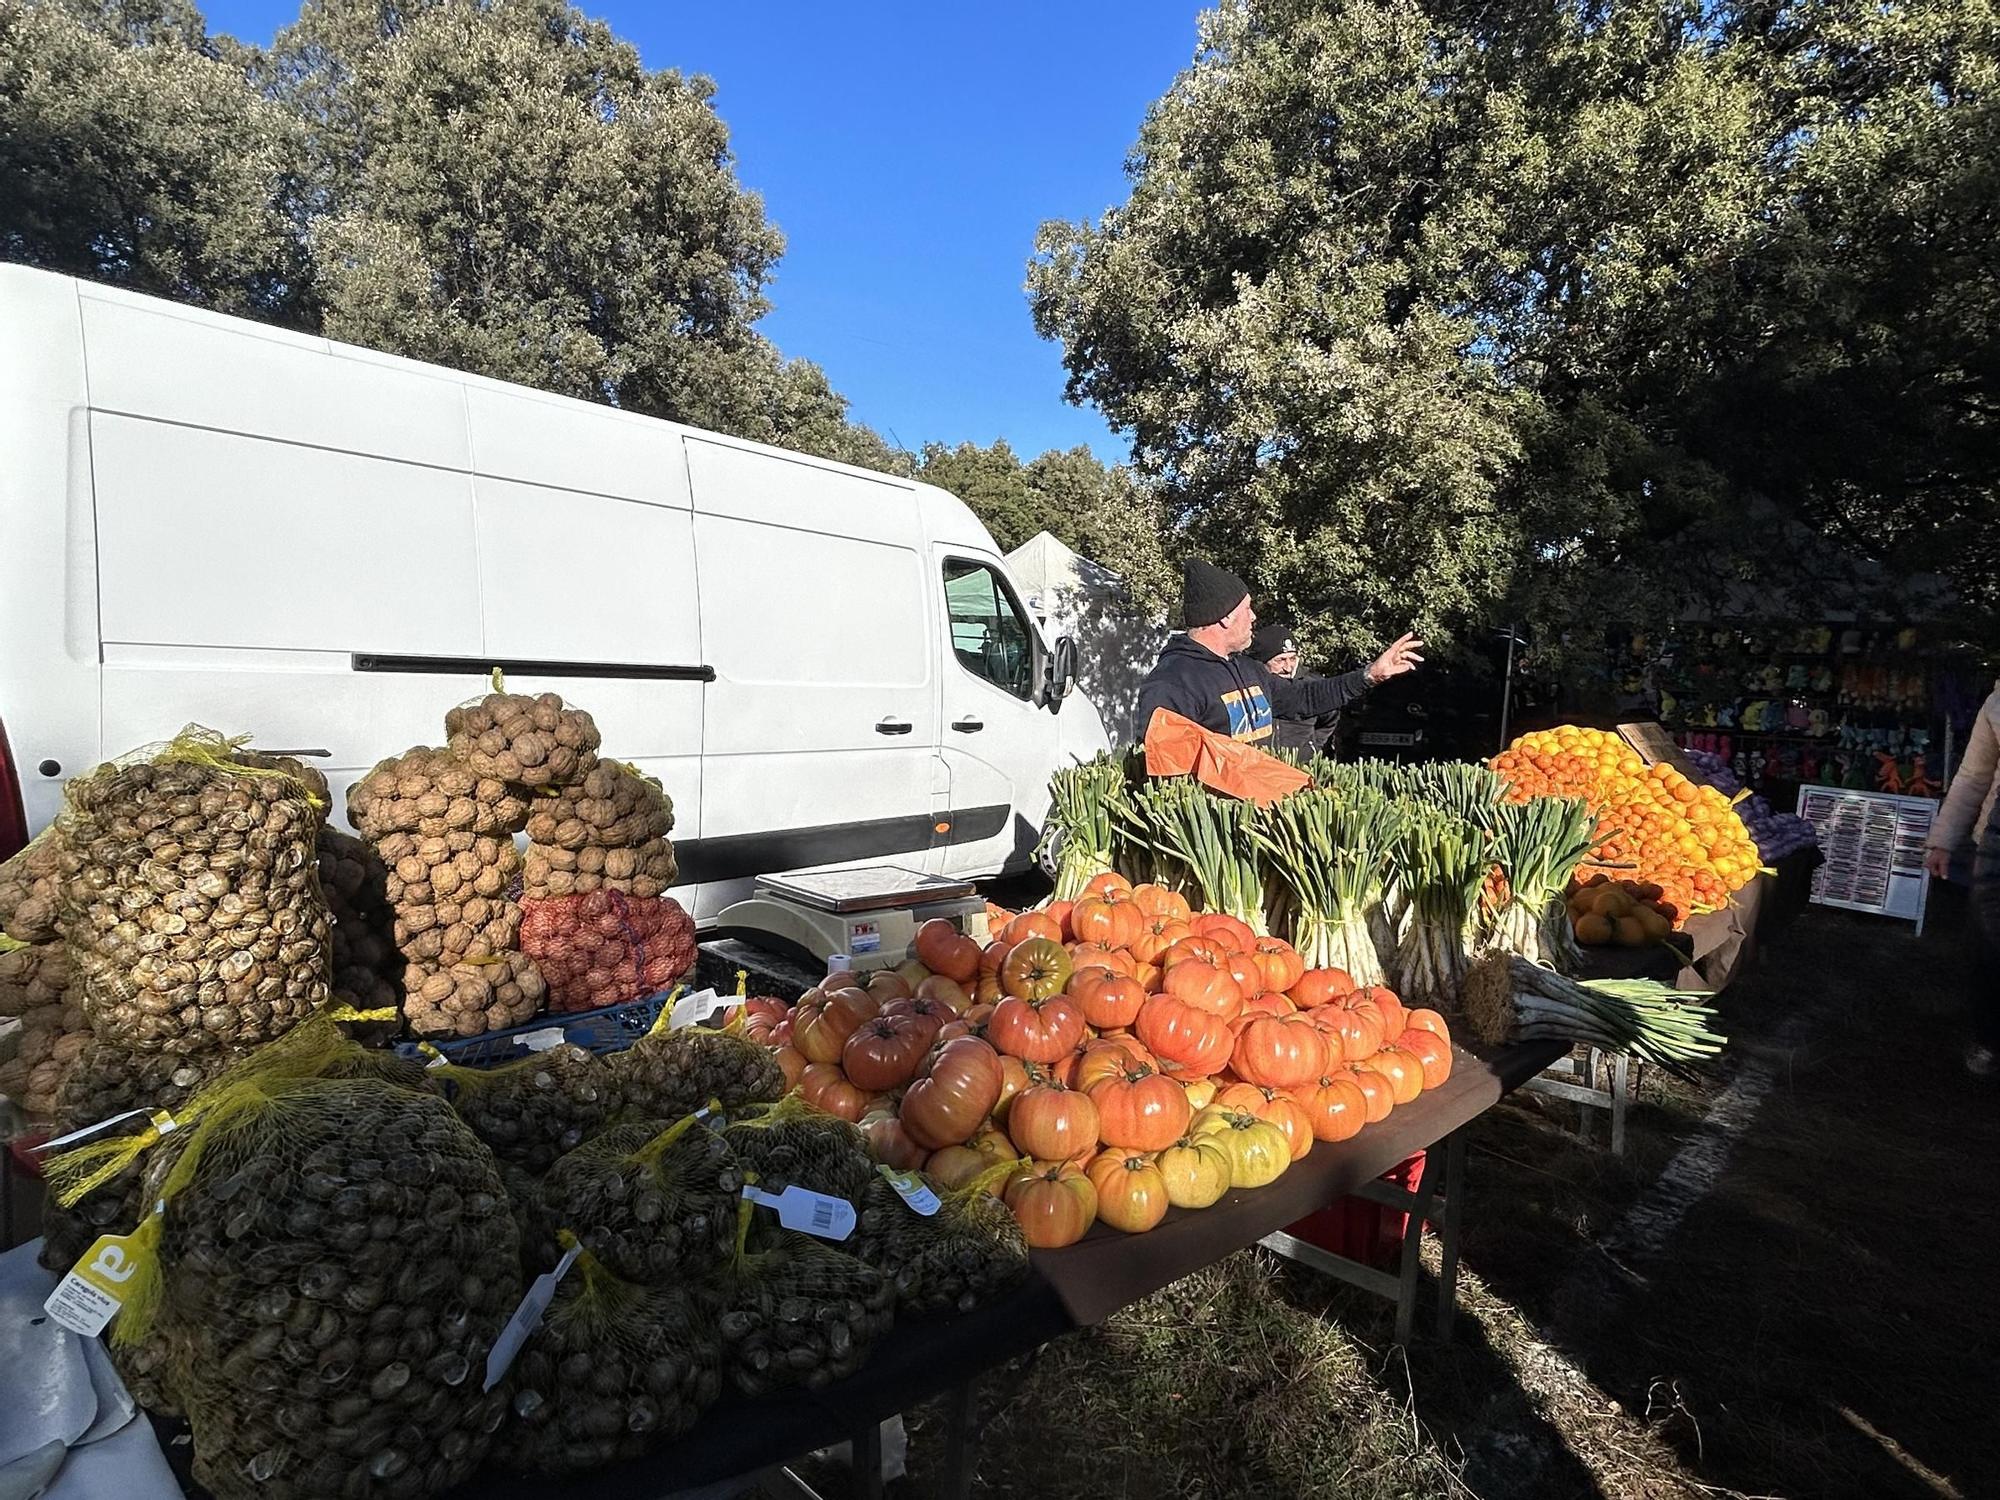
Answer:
[{"xmin": 348, "ymin": 746, "xmax": 544, "ymax": 1036}]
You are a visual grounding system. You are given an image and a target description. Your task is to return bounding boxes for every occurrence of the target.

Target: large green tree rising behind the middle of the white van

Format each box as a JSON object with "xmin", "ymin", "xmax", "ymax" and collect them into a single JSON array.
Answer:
[{"xmin": 260, "ymin": 0, "xmax": 908, "ymax": 472}]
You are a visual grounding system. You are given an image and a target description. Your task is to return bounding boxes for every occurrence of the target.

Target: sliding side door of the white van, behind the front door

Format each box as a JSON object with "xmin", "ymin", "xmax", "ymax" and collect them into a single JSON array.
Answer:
[{"xmin": 676, "ymin": 436, "xmax": 944, "ymax": 916}]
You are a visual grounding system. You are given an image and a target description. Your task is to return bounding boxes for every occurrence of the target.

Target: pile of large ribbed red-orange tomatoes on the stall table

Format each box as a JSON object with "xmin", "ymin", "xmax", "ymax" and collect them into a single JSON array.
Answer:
[{"xmin": 746, "ymin": 874, "xmax": 1452, "ymax": 1248}]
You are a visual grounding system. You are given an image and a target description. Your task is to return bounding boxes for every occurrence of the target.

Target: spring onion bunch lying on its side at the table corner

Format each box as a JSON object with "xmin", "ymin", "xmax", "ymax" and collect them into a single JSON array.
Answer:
[{"xmin": 1462, "ymin": 952, "xmax": 1724, "ymax": 1072}]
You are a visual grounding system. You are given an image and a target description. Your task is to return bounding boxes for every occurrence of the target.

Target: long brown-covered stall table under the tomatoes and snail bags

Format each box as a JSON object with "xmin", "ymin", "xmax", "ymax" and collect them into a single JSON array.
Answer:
[{"xmin": 454, "ymin": 1042, "xmax": 1562, "ymax": 1500}]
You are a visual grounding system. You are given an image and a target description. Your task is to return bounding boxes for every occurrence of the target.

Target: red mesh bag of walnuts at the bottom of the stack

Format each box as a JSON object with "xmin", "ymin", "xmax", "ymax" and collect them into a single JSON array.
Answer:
[{"xmin": 520, "ymin": 890, "xmax": 694, "ymax": 1010}]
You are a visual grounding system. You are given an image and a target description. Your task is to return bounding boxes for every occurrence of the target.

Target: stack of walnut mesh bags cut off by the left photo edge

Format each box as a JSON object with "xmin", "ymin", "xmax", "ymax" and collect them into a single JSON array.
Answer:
[{"xmin": 0, "ymin": 832, "xmax": 88, "ymax": 1120}]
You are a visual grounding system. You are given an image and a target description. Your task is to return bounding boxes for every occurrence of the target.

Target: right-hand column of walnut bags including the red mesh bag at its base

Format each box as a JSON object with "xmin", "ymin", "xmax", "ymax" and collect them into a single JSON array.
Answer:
[{"xmin": 520, "ymin": 760, "xmax": 694, "ymax": 1010}]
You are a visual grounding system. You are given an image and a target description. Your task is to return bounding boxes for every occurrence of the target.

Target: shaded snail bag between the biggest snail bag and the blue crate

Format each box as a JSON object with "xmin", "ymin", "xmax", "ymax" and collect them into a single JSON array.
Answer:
[{"xmin": 426, "ymin": 1042, "xmax": 624, "ymax": 1174}]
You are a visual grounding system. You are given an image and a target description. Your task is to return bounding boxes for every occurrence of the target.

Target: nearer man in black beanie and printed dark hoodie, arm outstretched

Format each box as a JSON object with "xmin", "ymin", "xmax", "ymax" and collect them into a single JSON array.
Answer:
[{"xmin": 1138, "ymin": 558, "xmax": 1424, "ymax": 748}]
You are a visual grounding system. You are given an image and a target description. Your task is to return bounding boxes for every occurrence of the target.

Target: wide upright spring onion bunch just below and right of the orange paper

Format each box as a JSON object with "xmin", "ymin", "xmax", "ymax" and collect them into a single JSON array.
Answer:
[{"xmin": 1252, "ymin": 786, "xmax": 1402, "ymax": 984}]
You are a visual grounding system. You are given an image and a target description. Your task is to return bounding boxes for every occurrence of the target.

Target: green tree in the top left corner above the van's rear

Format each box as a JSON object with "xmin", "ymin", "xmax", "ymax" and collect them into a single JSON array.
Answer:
[{"xmin": 0, "ymin": 0, "xmax": 310, "ymax": 322}]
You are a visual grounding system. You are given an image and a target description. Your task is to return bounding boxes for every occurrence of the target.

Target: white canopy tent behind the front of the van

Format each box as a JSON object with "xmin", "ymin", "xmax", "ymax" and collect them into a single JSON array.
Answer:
[{"xmin": 1006, "ymin": 532, "xmax": 1168, "ymax": 744}]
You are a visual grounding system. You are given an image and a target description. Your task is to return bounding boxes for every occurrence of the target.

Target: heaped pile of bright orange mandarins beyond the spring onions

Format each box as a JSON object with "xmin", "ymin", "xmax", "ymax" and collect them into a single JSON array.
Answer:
[{"xmin": 1492, "ymin": 724, "xmax": 1762, "ymax": 926}]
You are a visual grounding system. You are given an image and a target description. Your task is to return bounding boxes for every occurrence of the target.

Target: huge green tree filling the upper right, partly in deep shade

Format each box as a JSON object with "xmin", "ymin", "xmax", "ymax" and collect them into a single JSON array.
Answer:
[{"xmin": 1030, "ymin": 0, "xmax": 2000, "ymax": 652}]
